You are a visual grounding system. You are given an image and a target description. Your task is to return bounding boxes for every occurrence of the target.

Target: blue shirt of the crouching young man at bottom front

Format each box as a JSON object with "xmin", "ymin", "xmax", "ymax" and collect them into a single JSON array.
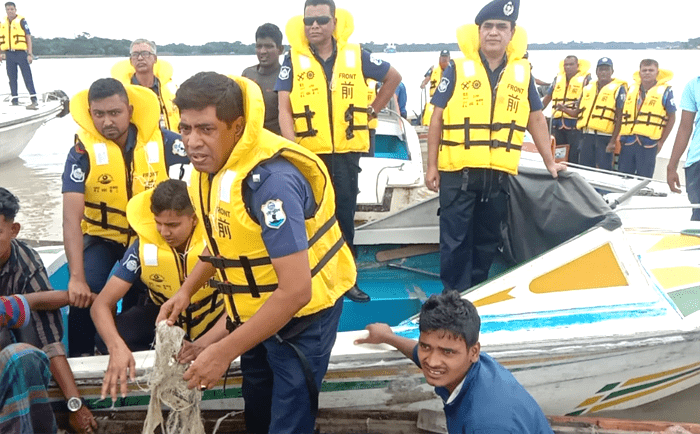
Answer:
[{"xmin": 413, "ymin": 345, "xmax": 553, "ymax": 434}]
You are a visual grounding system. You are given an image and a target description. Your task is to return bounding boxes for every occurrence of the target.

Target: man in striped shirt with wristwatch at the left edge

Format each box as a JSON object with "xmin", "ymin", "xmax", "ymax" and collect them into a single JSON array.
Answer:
[{"xmin": 0, "ymin": 187, "xmax": 97, "ymax": 433}]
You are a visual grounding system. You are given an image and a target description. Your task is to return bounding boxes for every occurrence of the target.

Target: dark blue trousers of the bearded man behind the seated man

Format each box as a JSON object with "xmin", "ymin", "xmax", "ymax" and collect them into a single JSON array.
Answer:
[{"xmin": 68, "ymin": 235, "xmax": 136, "ymax": 357}]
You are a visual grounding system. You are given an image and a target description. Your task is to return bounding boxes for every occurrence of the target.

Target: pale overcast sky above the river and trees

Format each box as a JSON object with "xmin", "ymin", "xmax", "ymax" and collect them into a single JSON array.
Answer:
[{"xmin": 15, "ymin": 0, "xmax": 700, "ymax": 45}]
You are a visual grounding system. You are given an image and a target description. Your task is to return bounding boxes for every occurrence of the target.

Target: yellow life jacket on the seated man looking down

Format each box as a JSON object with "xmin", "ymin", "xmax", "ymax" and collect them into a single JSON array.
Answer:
[{"xmin": 126, "ymin": 189, "xmax": 224, "ymax": 339}]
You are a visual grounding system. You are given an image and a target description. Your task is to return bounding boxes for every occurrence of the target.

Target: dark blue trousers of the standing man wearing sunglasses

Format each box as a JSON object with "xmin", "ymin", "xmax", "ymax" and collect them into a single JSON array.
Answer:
[{"xmin": 319, "ymin": 152, "xmax": 361, "ymax": 254}]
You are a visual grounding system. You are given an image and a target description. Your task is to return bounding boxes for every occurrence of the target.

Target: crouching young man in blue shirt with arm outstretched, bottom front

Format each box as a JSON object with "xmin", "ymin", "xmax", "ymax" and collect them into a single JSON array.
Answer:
[{"xmin": 355, "ymin": 292, "xmax": 552, "ymax": 434}]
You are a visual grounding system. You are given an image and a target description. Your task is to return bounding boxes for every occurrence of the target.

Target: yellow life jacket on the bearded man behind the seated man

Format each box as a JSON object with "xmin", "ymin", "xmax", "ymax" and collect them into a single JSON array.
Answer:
[{"xmin": 70, "ymin": 85, "xmax": 168, "ymax": 246}]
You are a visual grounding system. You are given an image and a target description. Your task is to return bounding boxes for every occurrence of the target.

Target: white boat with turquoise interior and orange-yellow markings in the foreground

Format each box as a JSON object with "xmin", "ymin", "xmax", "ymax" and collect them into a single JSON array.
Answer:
[{"xmin": 42, "ymin": 148, "xmax": 700, "ymax": 428}]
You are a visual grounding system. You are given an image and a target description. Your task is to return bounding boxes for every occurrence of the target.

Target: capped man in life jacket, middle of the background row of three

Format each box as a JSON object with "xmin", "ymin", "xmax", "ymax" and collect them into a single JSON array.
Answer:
[{"xmin": 576, "ymin": 57, "xmax": 627, "ymax": 170}]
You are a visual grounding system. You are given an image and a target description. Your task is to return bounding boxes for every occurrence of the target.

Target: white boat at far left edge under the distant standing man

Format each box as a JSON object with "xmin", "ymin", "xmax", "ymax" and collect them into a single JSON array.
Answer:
[{"xmin": 0, "ymin": 90, "xmax": 68, "ymax": 163}]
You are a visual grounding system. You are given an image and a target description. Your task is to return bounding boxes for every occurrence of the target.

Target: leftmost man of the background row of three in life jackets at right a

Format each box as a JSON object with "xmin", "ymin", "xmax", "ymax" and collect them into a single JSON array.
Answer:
[{"xmin": 542, "ymin": 56, "xmax": 591, "ymax": 163}]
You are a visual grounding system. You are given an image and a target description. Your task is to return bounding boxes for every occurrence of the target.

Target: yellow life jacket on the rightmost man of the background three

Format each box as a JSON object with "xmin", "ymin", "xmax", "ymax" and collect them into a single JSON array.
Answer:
[{"xmin": 620, "ymin": 69, "xmax": 673, "ymax": 140}]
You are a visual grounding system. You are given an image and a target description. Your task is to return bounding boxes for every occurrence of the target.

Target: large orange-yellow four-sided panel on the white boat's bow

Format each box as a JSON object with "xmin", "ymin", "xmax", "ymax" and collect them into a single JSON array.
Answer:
[{"xmin": 530, "ymin": 243, "xmax": 628, "ymax": 294}]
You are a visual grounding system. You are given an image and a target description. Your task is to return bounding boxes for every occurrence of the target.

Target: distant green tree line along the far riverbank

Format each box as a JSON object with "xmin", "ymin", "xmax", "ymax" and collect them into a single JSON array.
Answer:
[{"xmin": 32, "ymin": 33, "xmax": 700, "ymax": 57}]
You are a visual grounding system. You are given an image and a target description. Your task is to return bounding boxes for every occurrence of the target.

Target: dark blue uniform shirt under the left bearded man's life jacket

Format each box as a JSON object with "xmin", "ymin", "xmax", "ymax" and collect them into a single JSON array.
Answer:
[{"xmin": 61, "ymin": 125, "xmax": 190, "ymax": 194}]
